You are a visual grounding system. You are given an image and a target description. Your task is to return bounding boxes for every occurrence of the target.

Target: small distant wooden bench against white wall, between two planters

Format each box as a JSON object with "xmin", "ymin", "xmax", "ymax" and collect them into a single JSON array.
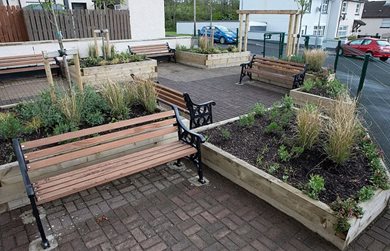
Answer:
[{"xmin": 128, "ymin": 43, "xmax": 176, "ymax": 63}]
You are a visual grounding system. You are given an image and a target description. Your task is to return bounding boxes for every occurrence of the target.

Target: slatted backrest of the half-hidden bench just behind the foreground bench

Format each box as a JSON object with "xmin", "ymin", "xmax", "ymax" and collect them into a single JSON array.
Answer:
[{"xmin": 154, "ymin": 83, "xmax": 189, "ymax": 114}]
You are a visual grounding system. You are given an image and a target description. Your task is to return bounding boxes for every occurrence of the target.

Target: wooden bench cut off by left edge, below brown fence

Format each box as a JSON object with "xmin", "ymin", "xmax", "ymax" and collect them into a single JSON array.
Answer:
[{"xmin": 0, "ymin": 54, "xmax": 60, "ymax": 75}]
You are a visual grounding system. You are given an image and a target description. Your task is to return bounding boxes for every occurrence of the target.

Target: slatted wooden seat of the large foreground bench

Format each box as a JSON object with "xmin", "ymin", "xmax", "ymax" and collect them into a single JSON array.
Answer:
[{"xmin": 36, "ymin": 141, "xmax": 193, "ymax": 193}]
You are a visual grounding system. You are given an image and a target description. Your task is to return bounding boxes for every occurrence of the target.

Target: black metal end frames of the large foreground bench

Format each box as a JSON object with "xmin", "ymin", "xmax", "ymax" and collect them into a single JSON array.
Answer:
[{"xmin": 12, "ymin": 105, "xmax": 206, "ymax": 249}]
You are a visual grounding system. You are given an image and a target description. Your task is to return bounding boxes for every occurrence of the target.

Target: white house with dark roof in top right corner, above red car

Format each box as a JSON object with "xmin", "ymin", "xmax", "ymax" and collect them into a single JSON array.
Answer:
[{"xmin": 359, "ymin": 0, "xmax": 390, "ymax": 38}]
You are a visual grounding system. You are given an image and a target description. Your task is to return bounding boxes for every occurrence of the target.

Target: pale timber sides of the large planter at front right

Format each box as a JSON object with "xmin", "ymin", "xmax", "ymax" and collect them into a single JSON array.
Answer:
[{"xmin": 197, "ymin": 115, "xmax": 390, "ymax": 250}]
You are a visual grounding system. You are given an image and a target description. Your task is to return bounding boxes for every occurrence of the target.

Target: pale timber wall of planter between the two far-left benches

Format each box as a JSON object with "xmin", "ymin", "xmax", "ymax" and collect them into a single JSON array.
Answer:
[{"xmin": 69, "ymin": 59, "xmax": 157, "ymax": 85}]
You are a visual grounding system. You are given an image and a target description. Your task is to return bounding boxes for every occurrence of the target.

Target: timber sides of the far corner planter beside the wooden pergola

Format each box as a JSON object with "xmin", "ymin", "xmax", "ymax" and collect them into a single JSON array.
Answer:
[{"xmin": 176, "ymin": 51, "xmax": 250, "ymax": 69}]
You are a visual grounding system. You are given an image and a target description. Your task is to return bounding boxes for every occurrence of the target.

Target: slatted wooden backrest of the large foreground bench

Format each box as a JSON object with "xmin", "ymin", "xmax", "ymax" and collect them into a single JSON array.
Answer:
[{"xmin": 21, "ymin": 111, "xmax": 178, "ymax": 170}]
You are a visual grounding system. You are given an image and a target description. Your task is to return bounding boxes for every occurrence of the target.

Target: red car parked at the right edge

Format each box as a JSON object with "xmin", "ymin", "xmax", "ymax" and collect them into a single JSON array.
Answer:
[{"xmin": 340, "ymin": 37, "xmax": 390, "ymax": 61}]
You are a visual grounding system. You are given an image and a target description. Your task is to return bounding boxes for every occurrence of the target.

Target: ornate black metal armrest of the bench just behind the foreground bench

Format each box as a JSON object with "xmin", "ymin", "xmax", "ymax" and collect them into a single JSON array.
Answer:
[{"xmin": 183, "ymin": 93, "xmax": 216, "ymax": 129}]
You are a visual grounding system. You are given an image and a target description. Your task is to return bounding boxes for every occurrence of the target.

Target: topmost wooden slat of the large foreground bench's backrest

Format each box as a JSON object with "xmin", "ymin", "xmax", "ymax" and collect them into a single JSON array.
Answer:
[{"xmin": 21, "ymin": 111, "xmax": 174, "ymax": 150}]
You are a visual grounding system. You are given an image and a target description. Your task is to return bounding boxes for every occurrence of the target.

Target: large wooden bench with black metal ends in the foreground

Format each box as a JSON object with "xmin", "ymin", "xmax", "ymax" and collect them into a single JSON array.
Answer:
[{"xmin": 13, "ymin": 106, "xmax": 205, "ymax": 248}]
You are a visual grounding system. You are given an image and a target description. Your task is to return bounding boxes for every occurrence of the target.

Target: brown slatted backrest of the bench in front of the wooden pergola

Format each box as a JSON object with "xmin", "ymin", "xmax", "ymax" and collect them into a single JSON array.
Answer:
[{"xmin": 252, "ymin": 55, "xmax": 305, "ymax": 76}]
